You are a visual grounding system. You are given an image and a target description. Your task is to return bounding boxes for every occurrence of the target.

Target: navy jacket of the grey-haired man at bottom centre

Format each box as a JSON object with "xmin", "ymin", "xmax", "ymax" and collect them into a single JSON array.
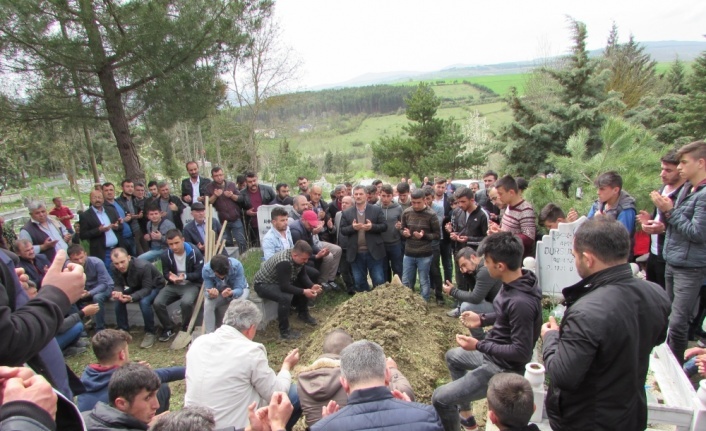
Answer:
[{"xmin": 311, "ymin": 386, "xmax": 444, "ymax": 431}]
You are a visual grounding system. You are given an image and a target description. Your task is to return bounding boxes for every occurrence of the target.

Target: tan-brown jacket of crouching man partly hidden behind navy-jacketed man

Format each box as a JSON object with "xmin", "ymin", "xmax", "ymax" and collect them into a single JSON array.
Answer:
[{"xmin": 297, "ymin": 354, "xmax": 414, "ymax": 427}]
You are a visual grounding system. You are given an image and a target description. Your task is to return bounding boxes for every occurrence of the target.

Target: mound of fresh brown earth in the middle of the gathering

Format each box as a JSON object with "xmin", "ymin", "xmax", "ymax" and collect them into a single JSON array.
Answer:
[{"xmin": 299, "ymin": 283, "xmax": 465, "ymax": 403}]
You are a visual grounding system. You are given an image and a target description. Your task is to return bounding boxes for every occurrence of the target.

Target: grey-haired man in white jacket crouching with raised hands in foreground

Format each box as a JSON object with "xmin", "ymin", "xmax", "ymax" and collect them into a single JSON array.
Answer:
[{"xmin": 184, "ymin": 300, "xmax": 301, "ymax": 430}]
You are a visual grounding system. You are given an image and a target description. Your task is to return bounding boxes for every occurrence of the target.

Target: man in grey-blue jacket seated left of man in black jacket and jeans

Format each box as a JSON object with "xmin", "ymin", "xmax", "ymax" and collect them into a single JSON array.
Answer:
[{"xmin": 68, "ymin": 244, "xmax": 113, "ymax": 333}]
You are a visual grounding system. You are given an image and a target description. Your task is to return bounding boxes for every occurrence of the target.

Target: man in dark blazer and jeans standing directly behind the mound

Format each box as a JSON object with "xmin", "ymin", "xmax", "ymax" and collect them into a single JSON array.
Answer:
[{"xmin": 340, "ymin": 186, "xmax": 387, "ymax": 292}]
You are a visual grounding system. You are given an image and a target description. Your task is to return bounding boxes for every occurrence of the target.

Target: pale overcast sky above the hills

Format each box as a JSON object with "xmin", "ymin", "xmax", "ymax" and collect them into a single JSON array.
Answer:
[{"xmin": 275, "ymin": 0, "xmax": 706, "ymax": 87}]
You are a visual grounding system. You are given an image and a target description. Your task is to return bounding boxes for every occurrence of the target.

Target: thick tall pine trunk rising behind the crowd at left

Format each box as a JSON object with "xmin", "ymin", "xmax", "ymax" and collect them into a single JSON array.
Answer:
[{"xmin": 79, "ymin": 0, "xmax": 145, "ymax": 181}]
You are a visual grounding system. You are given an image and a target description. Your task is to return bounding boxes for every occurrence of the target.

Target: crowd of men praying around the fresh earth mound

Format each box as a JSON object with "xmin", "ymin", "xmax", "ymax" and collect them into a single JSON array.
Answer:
[{"xmin": 0, "ymin": 141, "xmax": 706, "ymax": 431}]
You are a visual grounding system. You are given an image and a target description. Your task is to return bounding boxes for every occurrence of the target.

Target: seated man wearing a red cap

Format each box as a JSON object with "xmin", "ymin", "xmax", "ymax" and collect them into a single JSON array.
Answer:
[{"xmin": 289, "ymin": 210, "xmax": 341, "ymax": 290}]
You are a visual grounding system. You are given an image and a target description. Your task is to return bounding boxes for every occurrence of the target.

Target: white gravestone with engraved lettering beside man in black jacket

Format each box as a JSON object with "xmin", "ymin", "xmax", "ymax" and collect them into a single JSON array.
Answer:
[{"xmin": 535, "ymin": 216, "xmax": 588, "ymax": 299}]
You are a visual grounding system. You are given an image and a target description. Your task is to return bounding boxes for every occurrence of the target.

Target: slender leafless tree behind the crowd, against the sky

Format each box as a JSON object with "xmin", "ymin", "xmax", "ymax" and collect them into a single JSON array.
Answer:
[{"xmin": 232, "ymin": 16, "xmax": 302, "ymax": 171}]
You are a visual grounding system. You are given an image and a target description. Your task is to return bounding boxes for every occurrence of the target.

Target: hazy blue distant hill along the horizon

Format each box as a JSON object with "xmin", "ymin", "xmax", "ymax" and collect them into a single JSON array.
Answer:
[{"xmin": 312, "ymin": 40, "xmax": 706, "ymax": 91}]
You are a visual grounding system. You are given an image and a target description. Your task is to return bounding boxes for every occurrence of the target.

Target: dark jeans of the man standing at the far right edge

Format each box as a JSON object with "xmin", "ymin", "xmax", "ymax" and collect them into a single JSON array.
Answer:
[{"xmin": 664, "ymin": 264, "xmax": 706, "ymax": 364}]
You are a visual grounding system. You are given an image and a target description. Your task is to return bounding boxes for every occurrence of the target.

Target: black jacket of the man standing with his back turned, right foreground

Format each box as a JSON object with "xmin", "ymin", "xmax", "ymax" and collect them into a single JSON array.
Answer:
[{"xmin": 543, "ymin": 264, "xmax": 670, "ymax": 431}]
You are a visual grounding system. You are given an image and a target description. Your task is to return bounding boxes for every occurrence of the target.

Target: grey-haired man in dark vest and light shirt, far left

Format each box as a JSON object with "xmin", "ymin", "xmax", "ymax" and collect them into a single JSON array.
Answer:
[{"xmin": 19, "ymin": 201, "xmax": 71, "ymax": 262}]
